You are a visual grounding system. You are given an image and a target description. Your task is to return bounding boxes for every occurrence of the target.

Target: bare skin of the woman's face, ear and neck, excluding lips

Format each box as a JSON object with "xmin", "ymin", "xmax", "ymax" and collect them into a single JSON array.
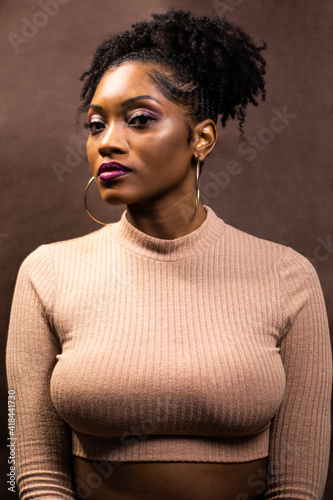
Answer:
[{"xmin": 87, "ymin": 62, "xmax": 217, "ymax": 239}]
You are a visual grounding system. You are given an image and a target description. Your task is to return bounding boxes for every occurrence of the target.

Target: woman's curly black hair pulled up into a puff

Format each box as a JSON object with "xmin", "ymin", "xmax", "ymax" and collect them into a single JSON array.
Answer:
[{"xmin": 79, "ymin": 9, "xmax": 266, "ymax": 141}]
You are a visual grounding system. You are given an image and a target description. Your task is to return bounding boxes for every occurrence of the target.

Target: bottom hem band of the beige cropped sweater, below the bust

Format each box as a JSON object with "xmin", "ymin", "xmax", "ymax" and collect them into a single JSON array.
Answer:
[{"xmin": 72, "ymin": 427, "xmax": 270, "ymax": 463}]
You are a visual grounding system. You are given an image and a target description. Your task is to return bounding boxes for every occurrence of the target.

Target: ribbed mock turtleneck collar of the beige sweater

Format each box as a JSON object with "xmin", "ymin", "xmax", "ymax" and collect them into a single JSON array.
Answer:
[{"xmin": 110, "ymin": 205, "xmax": 225, "ymax": 261}]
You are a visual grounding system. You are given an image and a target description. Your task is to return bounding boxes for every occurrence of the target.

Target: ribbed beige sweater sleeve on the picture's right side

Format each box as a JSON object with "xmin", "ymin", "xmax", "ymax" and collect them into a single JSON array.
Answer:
[{"xmin": 265, "ymin": 247, "xmax": 332, "ymax": 500}]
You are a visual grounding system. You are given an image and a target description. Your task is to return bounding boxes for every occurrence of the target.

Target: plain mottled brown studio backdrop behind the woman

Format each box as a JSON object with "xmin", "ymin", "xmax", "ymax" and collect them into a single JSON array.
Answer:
[{"xmin": 0, "ymin": 0, "xmax": 333, "ymax": 500}]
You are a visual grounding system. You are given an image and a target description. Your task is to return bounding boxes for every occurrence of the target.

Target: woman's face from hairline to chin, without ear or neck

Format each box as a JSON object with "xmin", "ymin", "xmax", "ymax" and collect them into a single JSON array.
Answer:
[{"xmin": 87, "ymin": 62, "xmax": 200, "ymax": 206}]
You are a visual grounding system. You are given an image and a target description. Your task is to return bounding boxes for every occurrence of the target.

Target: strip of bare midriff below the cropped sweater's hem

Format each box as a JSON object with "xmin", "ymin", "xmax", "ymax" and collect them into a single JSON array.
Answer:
[{"xmin": 73, "ymin": 455, "xmax": 267, "ymax": 500}]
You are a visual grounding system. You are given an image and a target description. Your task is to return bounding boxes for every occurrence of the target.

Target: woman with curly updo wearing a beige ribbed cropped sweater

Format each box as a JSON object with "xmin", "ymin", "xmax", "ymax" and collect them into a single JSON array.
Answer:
[{"xmin": 7, "ymin": 10, "xmax": 332, "ymax": 500}]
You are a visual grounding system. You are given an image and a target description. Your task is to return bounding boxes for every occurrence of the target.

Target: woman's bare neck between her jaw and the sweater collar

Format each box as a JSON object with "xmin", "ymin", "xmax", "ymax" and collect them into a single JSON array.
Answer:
[{"xmin": 127, "ymin": 199, "xmax": 207, "ymax": 240}]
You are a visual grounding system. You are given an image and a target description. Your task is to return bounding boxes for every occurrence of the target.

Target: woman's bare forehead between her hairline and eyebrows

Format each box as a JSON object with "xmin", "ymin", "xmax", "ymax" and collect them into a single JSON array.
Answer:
[{"xmin": 92, "ymin": 61, "xmax": 172, "ymax": 104}]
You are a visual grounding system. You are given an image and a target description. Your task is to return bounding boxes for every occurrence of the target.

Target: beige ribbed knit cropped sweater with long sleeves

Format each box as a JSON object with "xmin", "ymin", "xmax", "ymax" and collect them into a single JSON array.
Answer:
[{"xmin": 6, "ymin": 206, "xmax": 332, "ymax": 500}]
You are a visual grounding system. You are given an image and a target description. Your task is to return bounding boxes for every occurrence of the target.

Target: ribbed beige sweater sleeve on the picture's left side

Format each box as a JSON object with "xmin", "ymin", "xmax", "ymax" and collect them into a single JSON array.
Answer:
[{"xmin": 6, "ymin": 245, "xmax": 74, "ymax": 500}]
